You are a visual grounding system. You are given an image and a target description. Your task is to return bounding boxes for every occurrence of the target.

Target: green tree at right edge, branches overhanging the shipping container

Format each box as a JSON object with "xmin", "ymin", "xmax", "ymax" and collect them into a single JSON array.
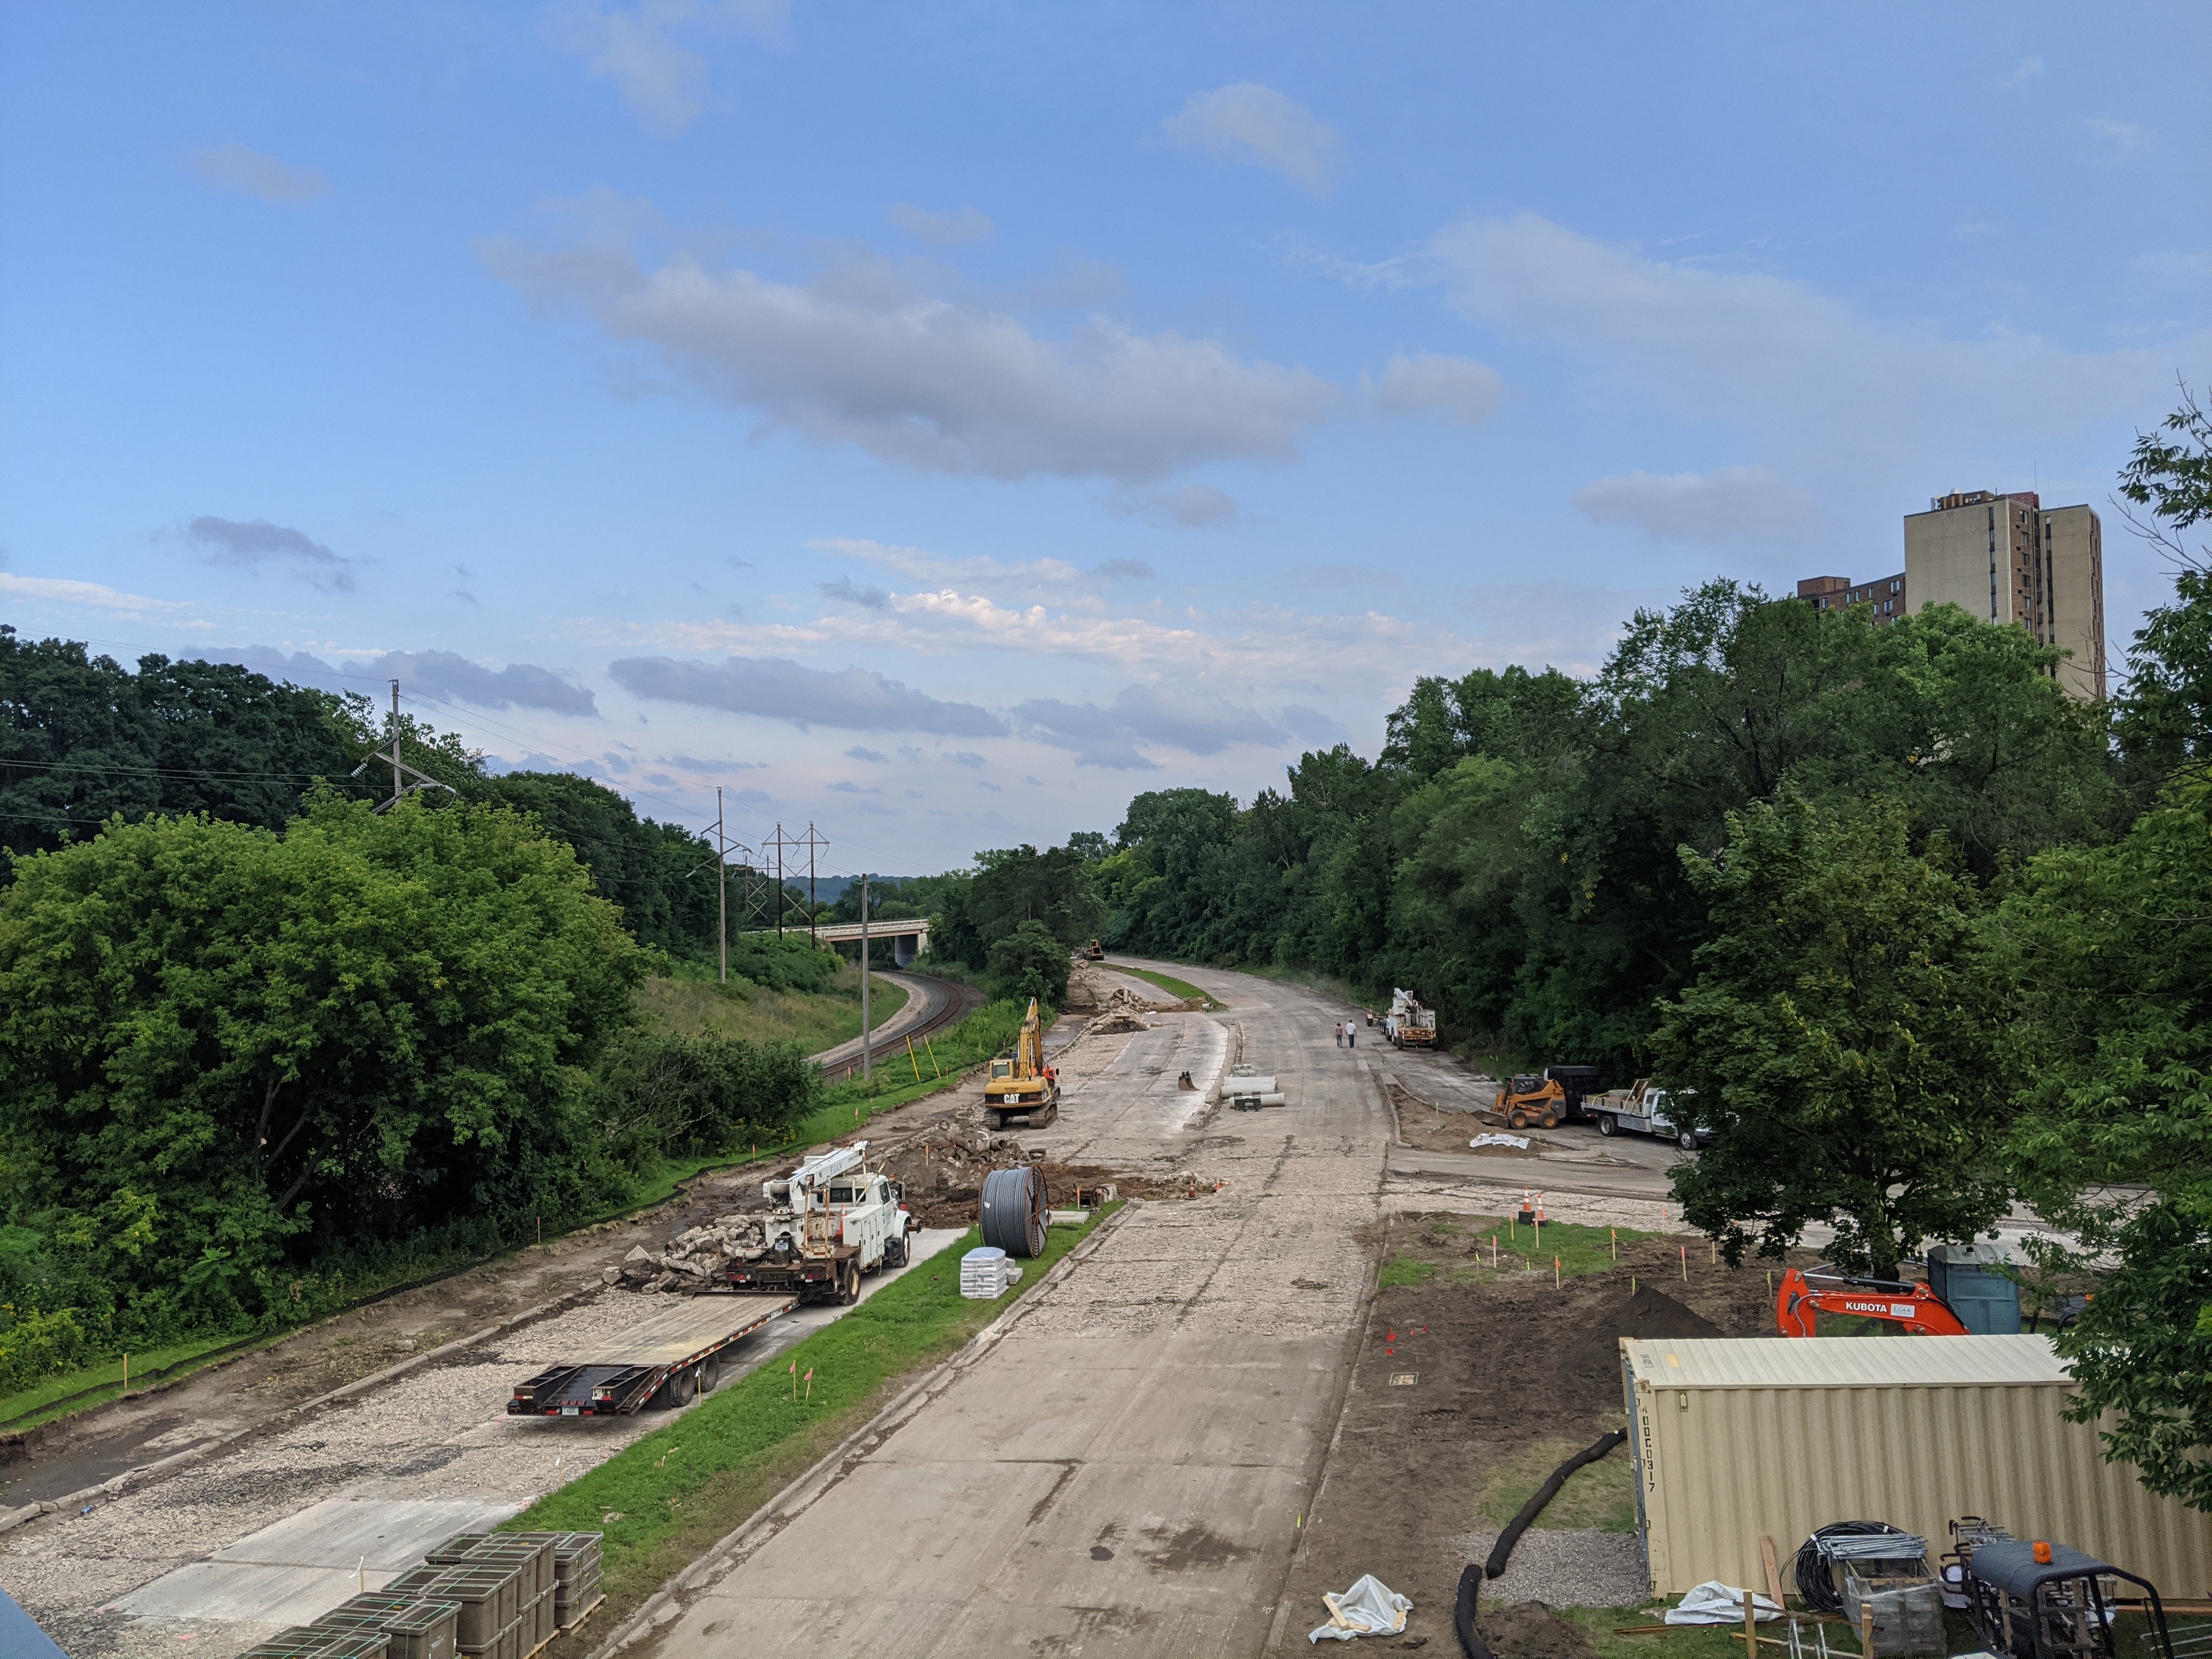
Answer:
[{"xmin": 1989, "ymin": 392, "xmax": 2212, "ymax": 1511}]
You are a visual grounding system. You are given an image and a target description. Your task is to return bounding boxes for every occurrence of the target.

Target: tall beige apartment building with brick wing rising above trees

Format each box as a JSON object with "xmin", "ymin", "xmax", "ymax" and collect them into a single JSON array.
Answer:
[{"xmin": 1798, "ymin": 489, "xmax": 2106, "ymax": 697}]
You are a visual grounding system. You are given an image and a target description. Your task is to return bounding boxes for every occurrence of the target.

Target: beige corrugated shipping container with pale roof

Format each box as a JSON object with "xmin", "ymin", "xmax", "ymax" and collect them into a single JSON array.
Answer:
[{"xmin": 1621, "ymin": 1336, "xmax": 2212, "ymax": 1599}]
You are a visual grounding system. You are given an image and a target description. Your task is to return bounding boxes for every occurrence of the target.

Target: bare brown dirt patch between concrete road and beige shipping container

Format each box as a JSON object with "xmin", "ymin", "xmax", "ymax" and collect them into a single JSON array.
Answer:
[{"xmin": 1278, "ymin": 1215, "xmax": 1809, "ymax": 1659}]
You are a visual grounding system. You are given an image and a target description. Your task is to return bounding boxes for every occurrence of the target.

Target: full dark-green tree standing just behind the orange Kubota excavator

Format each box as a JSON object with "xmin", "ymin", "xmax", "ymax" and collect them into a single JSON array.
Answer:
[{"xmin": 1652, "ymin": 794, "xmax": 2011, "ymax": 1278}]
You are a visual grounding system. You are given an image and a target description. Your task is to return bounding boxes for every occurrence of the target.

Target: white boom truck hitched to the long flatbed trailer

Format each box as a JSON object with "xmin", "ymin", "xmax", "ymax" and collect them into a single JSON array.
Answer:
[{"xmin": 728, "ymin": 1142, "xmax": 922, "ymax": 1305}]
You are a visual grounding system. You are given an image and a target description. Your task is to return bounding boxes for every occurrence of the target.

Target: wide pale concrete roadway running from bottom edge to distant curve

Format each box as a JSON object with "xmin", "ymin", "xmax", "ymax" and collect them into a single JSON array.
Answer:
[{"xmin": 637, "ymin": 967, "xmax": 1391, "ymax": 1659}]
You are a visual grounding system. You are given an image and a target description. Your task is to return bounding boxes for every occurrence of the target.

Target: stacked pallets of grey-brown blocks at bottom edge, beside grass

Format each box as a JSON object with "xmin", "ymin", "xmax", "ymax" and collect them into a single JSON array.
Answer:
[{"xmin": 239, "ymin": 1533, "xmax": 606, "ymax": 1659}]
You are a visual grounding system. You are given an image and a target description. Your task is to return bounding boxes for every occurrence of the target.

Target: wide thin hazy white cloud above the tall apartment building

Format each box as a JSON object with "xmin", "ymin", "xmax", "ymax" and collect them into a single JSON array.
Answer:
[{"xmin": 1431, "ymin": 212, "xmax": 2174, "ymax": 469}]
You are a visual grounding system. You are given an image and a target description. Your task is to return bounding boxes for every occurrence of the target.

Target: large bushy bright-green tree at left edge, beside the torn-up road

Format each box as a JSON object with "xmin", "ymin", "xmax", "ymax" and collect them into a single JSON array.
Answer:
[{"xmin": 0, "ymin": 797, "xmax": 639, "ymax": 1323}]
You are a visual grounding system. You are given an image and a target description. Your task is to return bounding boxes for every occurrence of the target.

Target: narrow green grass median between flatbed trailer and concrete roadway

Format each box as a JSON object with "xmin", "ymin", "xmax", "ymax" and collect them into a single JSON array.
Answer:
[{"xmin": 504, "ymin": 1205, "xmax": 1119, "ymax": 1639}]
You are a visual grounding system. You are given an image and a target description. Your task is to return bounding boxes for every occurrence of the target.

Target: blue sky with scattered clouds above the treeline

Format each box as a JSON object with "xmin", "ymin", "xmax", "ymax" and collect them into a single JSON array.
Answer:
[{"xmin": 0, "ymin": 0, "xmax": 2212, "ymax": 874}]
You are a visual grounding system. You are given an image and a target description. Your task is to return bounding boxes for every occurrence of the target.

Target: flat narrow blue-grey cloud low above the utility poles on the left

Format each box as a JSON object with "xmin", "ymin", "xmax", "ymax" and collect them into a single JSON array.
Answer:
[{"xmin": 606, "ymin": 657, "xmax": 1007, "ymax": 737}]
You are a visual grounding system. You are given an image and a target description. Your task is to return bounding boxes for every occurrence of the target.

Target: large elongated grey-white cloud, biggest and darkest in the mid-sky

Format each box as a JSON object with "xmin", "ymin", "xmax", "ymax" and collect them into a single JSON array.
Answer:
[{"xmin": 480, "ymin": 224, "xmax": 1340, "ymax": 482}]
